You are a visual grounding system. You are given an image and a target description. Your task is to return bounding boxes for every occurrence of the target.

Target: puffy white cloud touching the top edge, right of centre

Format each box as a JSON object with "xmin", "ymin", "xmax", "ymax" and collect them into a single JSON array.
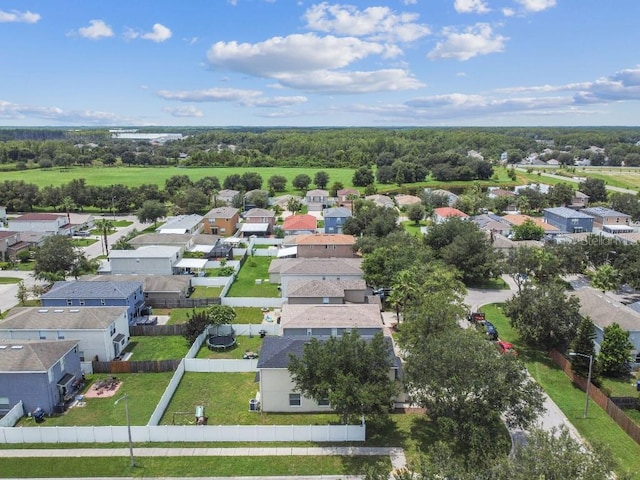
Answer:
[{"xmin": 304, "ymin": 2, "xmax": 431, "ymax": 42}]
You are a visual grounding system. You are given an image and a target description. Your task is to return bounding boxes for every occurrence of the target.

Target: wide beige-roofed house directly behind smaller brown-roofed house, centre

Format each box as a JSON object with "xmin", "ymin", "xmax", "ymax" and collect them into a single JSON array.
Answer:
[{"xmin": 269, "ymin": 258, "xmax": 363, "ymax": 298}]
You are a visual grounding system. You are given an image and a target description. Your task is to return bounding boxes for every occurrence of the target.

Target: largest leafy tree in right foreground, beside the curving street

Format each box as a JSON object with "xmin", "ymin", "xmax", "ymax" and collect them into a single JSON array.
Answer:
[{"xmin": 405, "ymin": 329, "xmax": 544, "ymax": 454}]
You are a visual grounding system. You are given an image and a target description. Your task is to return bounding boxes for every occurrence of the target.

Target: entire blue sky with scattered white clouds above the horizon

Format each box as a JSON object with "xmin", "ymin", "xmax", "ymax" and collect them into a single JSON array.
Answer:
[{"xmin": 0, "ymin": 0, "xmax": 640, "ymax": 126}]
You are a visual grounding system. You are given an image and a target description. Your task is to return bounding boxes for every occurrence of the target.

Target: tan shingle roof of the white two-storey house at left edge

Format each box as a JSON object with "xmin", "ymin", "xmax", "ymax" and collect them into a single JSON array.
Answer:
[{"xmin": 0, "ymin": 307, "xmax": 127, "ymax": 330}]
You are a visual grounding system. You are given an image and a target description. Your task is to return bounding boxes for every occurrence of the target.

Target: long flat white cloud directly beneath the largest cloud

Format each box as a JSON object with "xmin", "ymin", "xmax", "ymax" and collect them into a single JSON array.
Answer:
[{"xmin": 278, "ymin": 69, "xmax": 425, "ymax": 94}]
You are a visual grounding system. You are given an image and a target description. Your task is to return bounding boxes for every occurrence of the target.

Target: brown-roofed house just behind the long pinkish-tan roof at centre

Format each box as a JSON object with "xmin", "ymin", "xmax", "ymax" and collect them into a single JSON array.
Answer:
[{"xmin": 287, "ymin": 279, "xmax": 371, "ymax": 305}]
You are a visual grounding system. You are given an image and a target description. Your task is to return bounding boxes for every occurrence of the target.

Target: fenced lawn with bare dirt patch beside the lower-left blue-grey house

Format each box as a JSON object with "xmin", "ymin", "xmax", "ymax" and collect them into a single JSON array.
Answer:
[{"xmin": 18, "ymin": 372, "xmax": 173, "ymax": 427}]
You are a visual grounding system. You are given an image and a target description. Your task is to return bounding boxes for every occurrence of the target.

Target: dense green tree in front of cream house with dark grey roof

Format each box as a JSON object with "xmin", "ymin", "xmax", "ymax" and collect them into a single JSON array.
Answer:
[{"xmin": 288, "ymin": 331, "xmax": 397, "ymax": 423}]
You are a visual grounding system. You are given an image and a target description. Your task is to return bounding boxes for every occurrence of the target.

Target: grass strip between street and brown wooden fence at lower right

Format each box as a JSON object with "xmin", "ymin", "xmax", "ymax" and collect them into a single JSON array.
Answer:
[{"xmin": 481, "ymin": 305, "xmax": 640, "ymax": 478}]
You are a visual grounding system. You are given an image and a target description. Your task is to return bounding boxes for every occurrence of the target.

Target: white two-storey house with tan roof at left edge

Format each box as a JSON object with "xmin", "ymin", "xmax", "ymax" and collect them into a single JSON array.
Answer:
[{"xmin": 0, "ymin": 307, "xmax": 129, "ymax": 361}]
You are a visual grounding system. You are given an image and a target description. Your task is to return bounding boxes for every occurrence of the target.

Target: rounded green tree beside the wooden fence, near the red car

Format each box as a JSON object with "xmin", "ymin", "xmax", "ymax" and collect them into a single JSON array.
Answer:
[{"xmin": 504, "ymin": 282, "xmax": 582, "ymax": 351}]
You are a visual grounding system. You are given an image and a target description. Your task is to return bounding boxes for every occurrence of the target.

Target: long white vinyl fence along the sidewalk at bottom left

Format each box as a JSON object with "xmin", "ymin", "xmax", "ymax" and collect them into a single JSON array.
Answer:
[{"xmin": 0, "ymin": 424, "xmax": 366, "ymax": 444}]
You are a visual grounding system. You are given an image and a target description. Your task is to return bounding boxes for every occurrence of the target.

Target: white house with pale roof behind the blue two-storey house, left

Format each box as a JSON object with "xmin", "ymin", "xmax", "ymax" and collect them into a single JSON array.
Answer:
[{"xmin": 100, "ymin": 245, "xmax": 181, "ymax": 275}]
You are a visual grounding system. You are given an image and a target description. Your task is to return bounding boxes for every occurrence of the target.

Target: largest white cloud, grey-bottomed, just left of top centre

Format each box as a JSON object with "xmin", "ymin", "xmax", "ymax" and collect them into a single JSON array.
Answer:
[{"xmin": 207, "ymin": 33, "xmax": 394, "ymax": 78}]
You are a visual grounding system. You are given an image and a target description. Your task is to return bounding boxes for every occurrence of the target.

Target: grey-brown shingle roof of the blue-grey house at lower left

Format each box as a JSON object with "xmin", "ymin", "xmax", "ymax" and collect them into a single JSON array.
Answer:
[{"xmin": 0, "ymin": 340, "xmax": 78, "ymax": 373}]
